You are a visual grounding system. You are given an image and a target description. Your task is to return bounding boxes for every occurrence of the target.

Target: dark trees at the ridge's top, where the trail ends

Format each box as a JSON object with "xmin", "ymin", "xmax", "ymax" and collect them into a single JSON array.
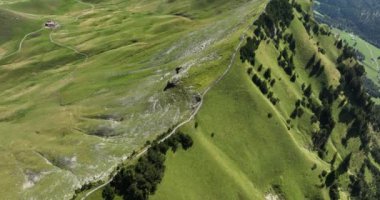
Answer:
[{"xmin": 240, "ymin": 0, "xmax": 302, "ymax": 108}]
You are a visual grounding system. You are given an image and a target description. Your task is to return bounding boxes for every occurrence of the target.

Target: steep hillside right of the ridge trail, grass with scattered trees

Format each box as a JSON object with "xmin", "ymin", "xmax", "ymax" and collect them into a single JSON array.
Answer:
[{"xmin": 151, "ymin": 1, "xmax": 380, "ymax": 200}]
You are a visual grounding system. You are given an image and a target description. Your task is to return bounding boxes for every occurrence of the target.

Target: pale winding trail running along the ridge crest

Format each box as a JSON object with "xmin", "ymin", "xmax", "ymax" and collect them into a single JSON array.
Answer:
[{"xmin": 81, "ymin": 23, "xmax": 251, "ymax": 200}]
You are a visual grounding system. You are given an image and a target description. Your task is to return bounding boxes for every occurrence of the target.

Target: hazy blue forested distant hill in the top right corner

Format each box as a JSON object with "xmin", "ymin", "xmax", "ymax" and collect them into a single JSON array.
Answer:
[{"xmin": 315, "ymin": 0, "xmax": 380, "ymax": 47}]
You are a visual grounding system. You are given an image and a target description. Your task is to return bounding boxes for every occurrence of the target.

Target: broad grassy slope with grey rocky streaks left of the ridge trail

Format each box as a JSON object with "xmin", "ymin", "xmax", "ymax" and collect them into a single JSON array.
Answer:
[{"xmin": 0, "ymin": 0, "xmax": 270, "ymax": 199}]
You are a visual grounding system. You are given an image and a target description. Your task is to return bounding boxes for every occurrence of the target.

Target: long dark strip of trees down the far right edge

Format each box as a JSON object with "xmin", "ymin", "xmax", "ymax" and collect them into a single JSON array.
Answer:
[{"xmin": 336, "ymin": 34, "xmax": 380, "ymax": 199}]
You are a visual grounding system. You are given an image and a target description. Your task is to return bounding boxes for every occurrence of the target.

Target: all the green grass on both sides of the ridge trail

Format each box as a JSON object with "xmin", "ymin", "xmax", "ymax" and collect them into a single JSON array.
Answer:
[{"xmin": 0, "ymin": 0, "xmax": 374, "ymax": 199}]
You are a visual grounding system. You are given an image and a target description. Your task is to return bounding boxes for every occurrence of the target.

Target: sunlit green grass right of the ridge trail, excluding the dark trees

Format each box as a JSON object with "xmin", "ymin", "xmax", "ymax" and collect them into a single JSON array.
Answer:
[{"xmin": 152, "ymin": 1, "xmax": 362, "ymax": 200}]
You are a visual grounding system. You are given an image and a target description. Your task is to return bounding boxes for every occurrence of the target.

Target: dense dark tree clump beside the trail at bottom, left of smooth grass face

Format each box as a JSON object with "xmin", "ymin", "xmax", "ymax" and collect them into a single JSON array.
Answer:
[{"xmin": 102, "ymin": 132, "xmax": 193, "ymax": 200}]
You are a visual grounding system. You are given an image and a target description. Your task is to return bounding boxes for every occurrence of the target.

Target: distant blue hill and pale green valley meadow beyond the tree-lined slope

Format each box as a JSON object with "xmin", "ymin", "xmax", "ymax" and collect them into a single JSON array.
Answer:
[{"xmin": 314, "ymin": 0, "xmax": 380, "ymax": 103}]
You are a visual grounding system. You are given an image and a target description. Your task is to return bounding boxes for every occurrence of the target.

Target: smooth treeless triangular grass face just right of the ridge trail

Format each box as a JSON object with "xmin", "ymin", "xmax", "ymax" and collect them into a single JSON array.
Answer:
[{"xmin": 152, "ymin": 25, "xmax": 325, "ymax": 199}]
